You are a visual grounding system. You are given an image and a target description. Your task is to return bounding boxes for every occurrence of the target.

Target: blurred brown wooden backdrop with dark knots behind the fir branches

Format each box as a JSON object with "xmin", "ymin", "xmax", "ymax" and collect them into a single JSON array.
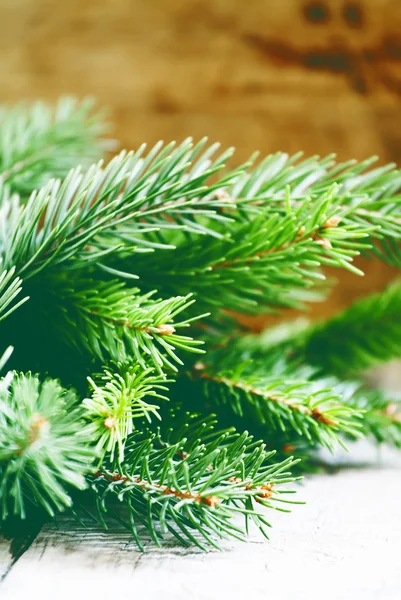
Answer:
[{"xmin": 0, "ymin": 0, "xmax": 401, "ymax": 324}]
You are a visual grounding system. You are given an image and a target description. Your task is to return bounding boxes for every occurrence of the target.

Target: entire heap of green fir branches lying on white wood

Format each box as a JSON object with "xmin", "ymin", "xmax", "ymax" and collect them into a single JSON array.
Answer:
[{"xmin": 0, "ymin": 100, "xmax": 401, "ymax": 548}]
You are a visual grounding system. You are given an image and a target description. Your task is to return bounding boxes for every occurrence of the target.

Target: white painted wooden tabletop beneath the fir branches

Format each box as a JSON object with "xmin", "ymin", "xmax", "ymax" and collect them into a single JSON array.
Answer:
[{"xmin": 0, "ymin": 446, "xmax": 401, "ymax": 600}]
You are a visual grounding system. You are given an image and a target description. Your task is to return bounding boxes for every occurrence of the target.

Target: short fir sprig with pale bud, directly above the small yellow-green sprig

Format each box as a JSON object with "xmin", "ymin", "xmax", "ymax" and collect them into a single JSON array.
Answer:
[{"xmin": 40, "ymin": 276, "xmax": 203, "ymax": 374}]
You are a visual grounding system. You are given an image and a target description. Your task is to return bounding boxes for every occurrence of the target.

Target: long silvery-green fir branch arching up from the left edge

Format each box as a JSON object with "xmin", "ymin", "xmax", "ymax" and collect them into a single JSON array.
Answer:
[{"xmin": 0, "ymin": 141, "xmax": 244, "ymax": 279}]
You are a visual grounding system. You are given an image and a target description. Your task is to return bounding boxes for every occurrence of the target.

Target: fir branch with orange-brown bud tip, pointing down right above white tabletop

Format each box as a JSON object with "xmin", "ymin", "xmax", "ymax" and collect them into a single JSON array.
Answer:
[{"xmin": 189, "ymin": 363, "xmax": 361, "ymax": 448}]
